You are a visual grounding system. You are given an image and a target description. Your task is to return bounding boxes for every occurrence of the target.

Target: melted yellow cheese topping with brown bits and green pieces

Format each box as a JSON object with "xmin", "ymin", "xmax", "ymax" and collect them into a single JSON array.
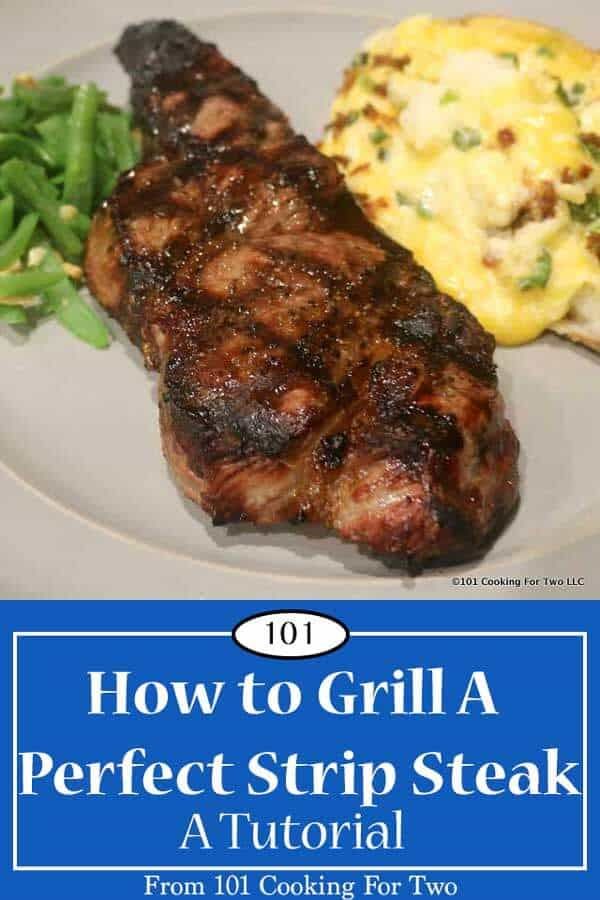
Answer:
[{"xmin": 322, "ymin": 16, "xmax": 600, "ymax": 344}]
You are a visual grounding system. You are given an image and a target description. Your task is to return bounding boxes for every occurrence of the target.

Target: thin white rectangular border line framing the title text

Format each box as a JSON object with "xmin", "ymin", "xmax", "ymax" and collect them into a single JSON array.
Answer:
[{"xmin": 12, "ymin": 631, "xmax": 589, "ymax": 873}]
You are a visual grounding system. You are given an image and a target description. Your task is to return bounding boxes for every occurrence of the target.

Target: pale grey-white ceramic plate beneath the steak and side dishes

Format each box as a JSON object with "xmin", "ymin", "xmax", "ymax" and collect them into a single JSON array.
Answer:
[{"xmin": 0, "ymin": 12, "xmax": 600, "ymax": 598}]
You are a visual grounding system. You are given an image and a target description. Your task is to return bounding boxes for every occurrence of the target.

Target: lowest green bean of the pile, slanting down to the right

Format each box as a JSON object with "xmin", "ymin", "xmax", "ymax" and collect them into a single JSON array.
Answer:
[{"xmin": 40, "ymin": 250, "xmax": 110, "ymax": 350}]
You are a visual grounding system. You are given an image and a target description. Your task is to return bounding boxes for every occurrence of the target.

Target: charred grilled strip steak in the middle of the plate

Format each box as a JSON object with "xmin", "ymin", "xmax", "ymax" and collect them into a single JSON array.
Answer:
[{"xmin": 86, "ymin": 22, "xmax": 518, "ymax": 570}]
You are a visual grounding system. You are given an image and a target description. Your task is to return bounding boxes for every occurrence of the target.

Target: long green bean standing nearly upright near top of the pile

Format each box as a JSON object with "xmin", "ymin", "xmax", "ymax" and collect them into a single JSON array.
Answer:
[{"xmin": 63, "ymin": 83, "xmax": 98, "ymax": 215}]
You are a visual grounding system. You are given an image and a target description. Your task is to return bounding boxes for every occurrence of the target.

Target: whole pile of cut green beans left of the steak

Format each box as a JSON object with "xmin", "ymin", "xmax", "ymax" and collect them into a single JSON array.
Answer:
[{"xmin": 0, "ymin": 76, "xmax": 140, "ymax": 348}]
